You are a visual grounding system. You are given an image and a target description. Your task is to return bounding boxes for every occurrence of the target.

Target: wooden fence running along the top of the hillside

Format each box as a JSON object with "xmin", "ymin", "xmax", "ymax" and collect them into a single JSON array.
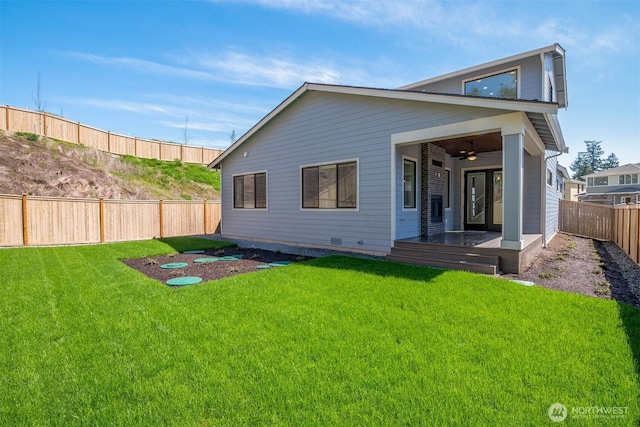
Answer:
[{"xmin": 0, "ymin": 105, "xmax": 223, "ymax": 164}]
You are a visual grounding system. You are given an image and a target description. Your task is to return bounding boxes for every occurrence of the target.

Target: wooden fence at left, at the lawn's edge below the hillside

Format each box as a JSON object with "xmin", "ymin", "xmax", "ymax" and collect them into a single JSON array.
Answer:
[{"xmin": 0, "ymin": 195, "xmax": 220, "ymax": 246}]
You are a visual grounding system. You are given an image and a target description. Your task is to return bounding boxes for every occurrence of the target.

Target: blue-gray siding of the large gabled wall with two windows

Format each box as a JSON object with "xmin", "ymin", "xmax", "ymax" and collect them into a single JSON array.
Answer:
[{"xmin": 222, "ymin": 92, "xmax": 504, "ymax": 252}]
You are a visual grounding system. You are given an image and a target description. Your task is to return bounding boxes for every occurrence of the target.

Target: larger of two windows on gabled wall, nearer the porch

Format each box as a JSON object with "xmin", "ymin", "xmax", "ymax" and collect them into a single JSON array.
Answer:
[{"xmin": 302, "ymin": 162, "xmax": 358, "ymax": 209}]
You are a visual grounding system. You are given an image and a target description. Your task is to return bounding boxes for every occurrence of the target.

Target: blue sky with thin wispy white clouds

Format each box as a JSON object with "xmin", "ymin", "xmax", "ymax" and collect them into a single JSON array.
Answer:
[{"xmin": 0, "ymin": 0, "xmax": 640, "ymax": 171}]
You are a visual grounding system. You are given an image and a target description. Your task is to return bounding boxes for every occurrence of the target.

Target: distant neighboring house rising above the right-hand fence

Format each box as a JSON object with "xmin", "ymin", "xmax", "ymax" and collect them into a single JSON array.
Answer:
[{"xmin": 579, "ymin": 163, "xmax": 640, "ymax": 205}]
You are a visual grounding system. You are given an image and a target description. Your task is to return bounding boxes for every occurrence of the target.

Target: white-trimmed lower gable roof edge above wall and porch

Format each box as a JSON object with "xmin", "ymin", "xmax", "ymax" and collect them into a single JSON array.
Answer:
[{"xmin": 208, "ymin": 83, "xmax": 566, "ymax": 168}]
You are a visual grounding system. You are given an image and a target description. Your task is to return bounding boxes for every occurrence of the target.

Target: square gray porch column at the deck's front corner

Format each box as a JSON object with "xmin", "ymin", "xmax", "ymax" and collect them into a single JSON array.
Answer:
[{"xmin": 500, "ymin": 133, "xmax": 524, "ymax": 250}]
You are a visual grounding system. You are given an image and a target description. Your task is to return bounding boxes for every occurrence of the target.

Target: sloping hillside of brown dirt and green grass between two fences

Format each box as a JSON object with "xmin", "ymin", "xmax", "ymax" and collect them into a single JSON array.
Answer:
[{"xmin": 0, "ymin": 131, "xmax": 220, "ymax": 200}]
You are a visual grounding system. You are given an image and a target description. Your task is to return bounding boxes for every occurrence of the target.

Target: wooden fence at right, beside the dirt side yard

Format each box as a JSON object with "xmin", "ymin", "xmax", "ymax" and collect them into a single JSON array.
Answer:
[{"xmin": 560, "ymin": 200, "xmax": 640, "ymax": 264}]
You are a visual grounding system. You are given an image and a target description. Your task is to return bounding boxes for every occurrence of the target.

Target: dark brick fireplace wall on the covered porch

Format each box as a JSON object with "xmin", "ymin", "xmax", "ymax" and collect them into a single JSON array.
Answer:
[{"xmin": 420, "ymin": 143, "xmax": 446, "ymax": 236}]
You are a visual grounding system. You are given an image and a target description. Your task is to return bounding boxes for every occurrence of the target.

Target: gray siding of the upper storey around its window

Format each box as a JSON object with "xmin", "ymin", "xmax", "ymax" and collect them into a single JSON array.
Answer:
[{"xmin": 413, "ymin": 56, "xmax": 544, "ymax": 101}]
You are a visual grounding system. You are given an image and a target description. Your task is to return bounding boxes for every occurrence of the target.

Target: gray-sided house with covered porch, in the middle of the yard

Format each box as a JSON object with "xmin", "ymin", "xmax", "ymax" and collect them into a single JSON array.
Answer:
[{"xmin": 209, "ymin": 44, "xmax": 567, "ymax": 274}]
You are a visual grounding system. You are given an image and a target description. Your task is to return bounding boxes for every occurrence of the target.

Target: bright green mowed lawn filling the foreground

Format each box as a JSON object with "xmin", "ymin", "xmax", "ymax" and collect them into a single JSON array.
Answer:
[{"xmin": 0, "ymin": 239, "xmax": 640, "ymax": 426}]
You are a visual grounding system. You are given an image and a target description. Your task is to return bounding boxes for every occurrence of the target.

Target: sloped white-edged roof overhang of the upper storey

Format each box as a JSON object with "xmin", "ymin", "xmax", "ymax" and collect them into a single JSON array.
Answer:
[{"xmin": 399, "ymin": 43, "xmax": 568, "ymax": 108}]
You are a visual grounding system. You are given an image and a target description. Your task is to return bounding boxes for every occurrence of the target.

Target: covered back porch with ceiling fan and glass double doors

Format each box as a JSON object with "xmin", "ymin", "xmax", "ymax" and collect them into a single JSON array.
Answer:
[{"xmin": 387, "ymin": 113, "xmax": 554, "ymax": 274}]
